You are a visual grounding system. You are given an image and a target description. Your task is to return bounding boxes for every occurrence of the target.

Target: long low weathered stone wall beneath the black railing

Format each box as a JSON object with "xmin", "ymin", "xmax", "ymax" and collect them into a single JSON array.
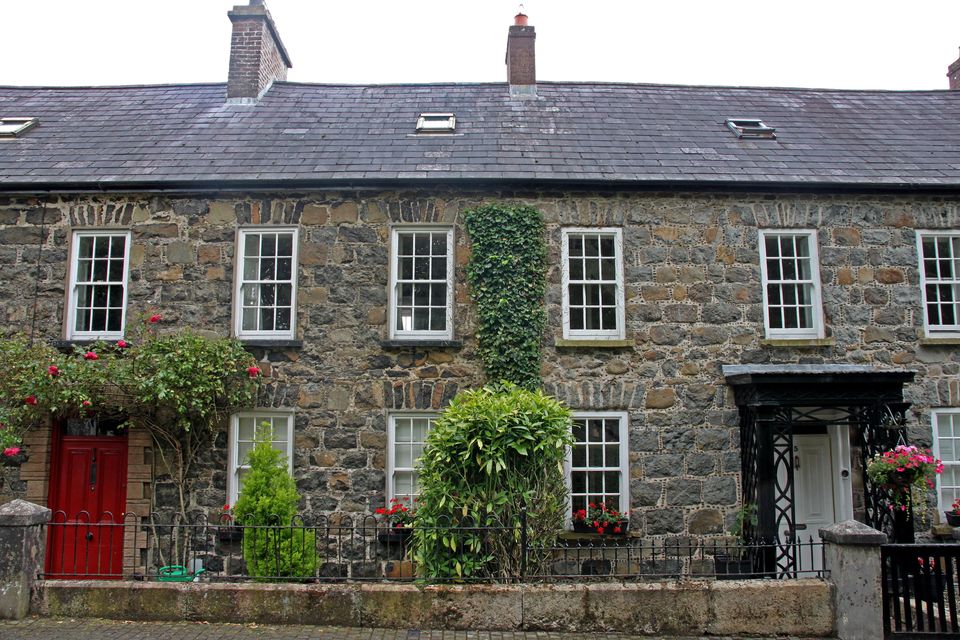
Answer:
[{"xmin": 33, "ymin": 579, "xmax": 835, "ymax": 637}]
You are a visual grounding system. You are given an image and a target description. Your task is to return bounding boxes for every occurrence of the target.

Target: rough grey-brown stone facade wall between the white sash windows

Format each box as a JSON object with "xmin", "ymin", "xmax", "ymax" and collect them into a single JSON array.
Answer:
[{"xmin": 0, "ymin": 192, "xmax": 960, "ymax": 535}]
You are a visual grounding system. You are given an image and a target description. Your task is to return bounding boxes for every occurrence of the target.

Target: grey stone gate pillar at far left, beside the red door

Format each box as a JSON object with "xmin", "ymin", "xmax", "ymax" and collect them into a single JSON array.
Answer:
[{"xmin": 0, "ymin": 500, "xmax": 50, "ymax": 620}]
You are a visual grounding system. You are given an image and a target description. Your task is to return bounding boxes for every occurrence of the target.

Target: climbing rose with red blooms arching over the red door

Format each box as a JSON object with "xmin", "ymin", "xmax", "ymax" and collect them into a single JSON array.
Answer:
[{"xmin": 0, "ymin": 313, "xmax": 261, "ymax": 511}]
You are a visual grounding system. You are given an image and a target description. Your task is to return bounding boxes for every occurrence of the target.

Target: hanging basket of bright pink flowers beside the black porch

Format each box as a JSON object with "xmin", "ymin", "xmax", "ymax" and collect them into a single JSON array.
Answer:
[{"xmin": 867, "ymin": 444, "xmax": 943, "ymax": 513}]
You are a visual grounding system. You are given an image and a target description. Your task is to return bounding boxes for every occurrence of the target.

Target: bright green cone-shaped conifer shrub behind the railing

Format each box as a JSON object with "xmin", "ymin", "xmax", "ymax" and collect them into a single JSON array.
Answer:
[{"xmin": 234, "ymin": 424, "xmax": 317, "ymax": 580}]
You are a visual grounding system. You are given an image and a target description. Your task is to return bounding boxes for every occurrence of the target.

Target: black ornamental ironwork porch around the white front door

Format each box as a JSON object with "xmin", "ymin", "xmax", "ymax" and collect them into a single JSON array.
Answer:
[{"xmin": 723, "ymin": 365, "xmax": 914, "ymax": 575}]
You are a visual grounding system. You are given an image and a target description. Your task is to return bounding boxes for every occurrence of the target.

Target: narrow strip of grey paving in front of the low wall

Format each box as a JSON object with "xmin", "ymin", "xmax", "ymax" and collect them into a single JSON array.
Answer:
[{"xmin": 0, "ymin": 618, "xmax": 813, "ymax": 640}]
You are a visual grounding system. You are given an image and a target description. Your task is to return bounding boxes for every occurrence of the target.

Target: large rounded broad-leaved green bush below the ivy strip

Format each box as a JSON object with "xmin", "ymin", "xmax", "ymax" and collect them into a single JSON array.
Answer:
[{"xmin": 413, "ymin": 383, "xmax": 571, "ymax": 579}]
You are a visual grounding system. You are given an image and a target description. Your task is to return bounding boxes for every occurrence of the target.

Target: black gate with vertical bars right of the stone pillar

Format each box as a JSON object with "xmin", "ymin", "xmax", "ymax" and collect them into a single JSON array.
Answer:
[{"xmin": 880, "ymin": 544, "xmax": 960, "ymax": 638}]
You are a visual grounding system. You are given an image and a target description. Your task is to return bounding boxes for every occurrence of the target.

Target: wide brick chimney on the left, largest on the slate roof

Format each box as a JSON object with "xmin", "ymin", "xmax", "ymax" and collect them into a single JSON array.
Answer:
[{"xmin": 227, "ymin": 0, "xmax": 293, "ymax": 102}]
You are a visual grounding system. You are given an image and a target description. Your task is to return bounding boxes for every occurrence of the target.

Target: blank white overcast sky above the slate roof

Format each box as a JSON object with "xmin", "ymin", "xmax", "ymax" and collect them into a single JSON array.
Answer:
[{"xmin": 0, "ymin": 0, "xmax": 960, "ymax": 89}]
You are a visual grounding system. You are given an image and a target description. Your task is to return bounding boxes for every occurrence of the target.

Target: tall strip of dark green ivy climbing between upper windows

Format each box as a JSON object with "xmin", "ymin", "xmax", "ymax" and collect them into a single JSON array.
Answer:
[{"xmin": 465, "ymin": 205, "xmax": 547, "ymax": 389}]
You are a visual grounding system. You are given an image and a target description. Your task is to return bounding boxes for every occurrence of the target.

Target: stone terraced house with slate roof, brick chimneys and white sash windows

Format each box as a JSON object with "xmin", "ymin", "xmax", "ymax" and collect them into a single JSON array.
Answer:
[{"xmin": 0, "ymin": 1, "xmax": 960, "ymax": 568}]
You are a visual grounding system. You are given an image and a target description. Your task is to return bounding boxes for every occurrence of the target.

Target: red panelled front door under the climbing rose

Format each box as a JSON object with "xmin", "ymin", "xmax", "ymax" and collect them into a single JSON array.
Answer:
[{"xmin": 47, "ymin": 435, "xmax": 127, "ymax": 580}]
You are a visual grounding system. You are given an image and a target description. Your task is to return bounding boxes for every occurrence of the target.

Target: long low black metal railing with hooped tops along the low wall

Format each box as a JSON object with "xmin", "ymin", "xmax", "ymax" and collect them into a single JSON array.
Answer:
[{"xmin": 41, "ymin": 513, "xmax": 824, "ymax": 582}]
